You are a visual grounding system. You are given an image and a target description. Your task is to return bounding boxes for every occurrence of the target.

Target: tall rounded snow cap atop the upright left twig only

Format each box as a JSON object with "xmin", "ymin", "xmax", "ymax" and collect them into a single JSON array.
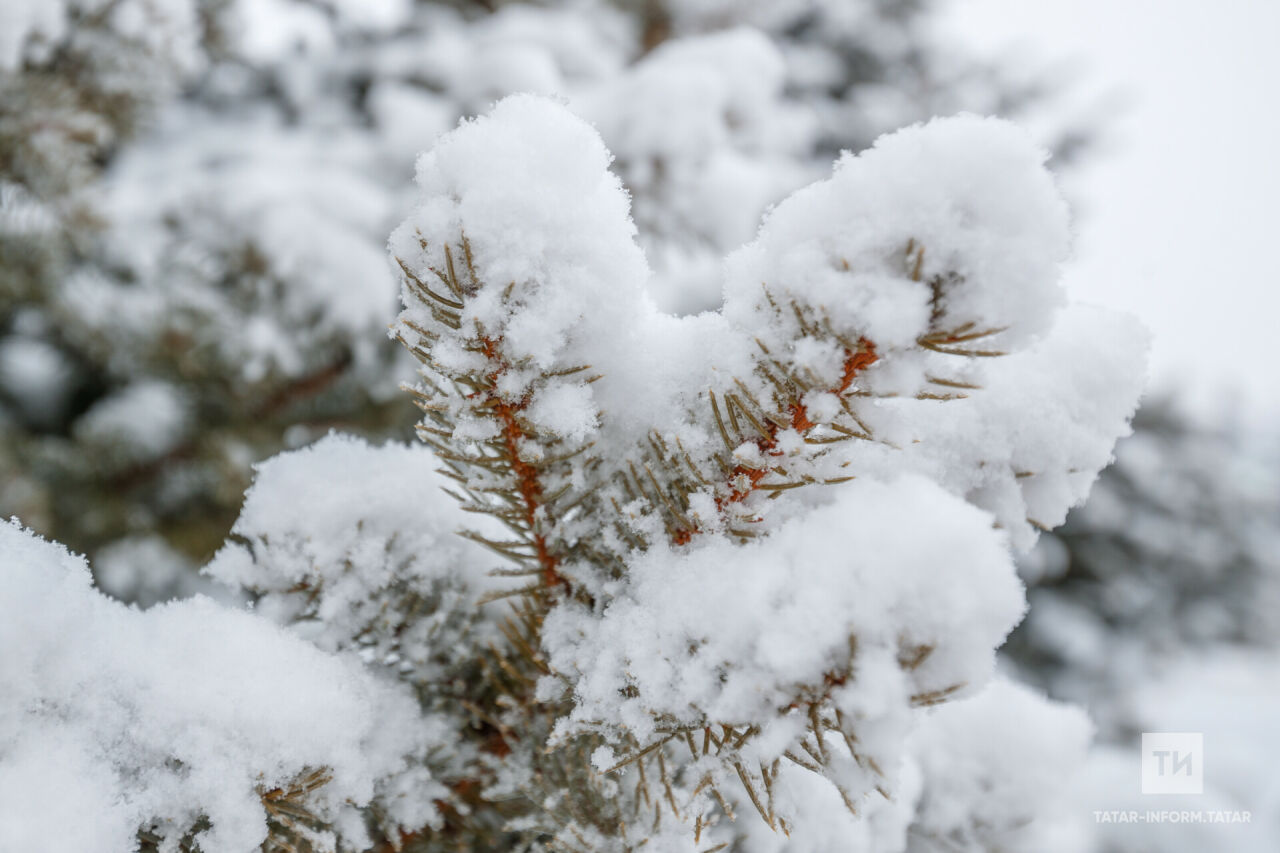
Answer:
[{"xmin": 392, "ymin": 90, "xmax": 648, "ymax": 369}]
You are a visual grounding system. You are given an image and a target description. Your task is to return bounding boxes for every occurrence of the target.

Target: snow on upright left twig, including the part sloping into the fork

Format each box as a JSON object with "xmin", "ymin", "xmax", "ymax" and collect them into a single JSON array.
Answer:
[{"xmin": 390, "ymin": 96, "xmax": 742, "ymax": 466}]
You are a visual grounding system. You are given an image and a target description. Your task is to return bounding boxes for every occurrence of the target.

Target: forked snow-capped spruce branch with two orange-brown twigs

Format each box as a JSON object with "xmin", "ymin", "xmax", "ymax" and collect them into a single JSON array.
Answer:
[{"xmin": 373, "ymin": 101, "xmax": 1146, "ymax": 850}]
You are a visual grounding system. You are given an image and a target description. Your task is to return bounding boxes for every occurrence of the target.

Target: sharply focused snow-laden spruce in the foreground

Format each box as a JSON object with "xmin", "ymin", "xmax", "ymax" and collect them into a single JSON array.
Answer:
[{"xmin": 0, "ymin": 96, "xmax": 1144, "ymax": 853}]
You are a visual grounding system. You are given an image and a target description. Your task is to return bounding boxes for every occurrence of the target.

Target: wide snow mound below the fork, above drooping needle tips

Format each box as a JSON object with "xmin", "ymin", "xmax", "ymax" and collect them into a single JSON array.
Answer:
[{"xmin": 544, "ymin": 478, "xmax": 1024, "ymax": 742}]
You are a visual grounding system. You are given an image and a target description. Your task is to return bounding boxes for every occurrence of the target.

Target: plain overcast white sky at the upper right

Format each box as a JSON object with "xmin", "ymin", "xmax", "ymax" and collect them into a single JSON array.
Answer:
[{"xmin": 947, "ymin": 0, "xmax": 1280, "ymax": 416}]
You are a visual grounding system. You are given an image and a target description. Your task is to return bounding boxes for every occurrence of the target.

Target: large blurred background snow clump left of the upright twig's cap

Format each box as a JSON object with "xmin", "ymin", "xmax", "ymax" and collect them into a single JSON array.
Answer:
[{"xmin": 58, "ymin": 105, "xmax": 394, "ymax": 384}]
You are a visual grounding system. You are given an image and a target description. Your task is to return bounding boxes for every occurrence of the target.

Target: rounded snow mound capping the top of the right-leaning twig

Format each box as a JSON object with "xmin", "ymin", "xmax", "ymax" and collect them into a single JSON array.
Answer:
[{"xmin": 724, "ymin": 115, "xmax": 1070, "ymax": 348}]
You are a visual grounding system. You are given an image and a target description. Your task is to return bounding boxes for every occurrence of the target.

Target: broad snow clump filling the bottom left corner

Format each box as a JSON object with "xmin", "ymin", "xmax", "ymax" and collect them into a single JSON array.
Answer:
[{"xmin": 0, "ymin": 524, "xmax": 433, "ymax": 853}]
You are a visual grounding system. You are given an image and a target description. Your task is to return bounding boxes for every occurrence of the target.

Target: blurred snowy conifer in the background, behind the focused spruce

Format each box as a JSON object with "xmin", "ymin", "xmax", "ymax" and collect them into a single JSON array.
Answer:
[{"xmin": 0, "ymin": 0, "xmax": 1100, "ymax": 589}]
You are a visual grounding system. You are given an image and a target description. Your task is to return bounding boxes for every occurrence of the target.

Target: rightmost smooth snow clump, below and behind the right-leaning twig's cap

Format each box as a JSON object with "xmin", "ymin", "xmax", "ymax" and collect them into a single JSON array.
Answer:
[{"xmin": 886, "ymin": 305, "xmax": 1147, "ymax": 551}]
